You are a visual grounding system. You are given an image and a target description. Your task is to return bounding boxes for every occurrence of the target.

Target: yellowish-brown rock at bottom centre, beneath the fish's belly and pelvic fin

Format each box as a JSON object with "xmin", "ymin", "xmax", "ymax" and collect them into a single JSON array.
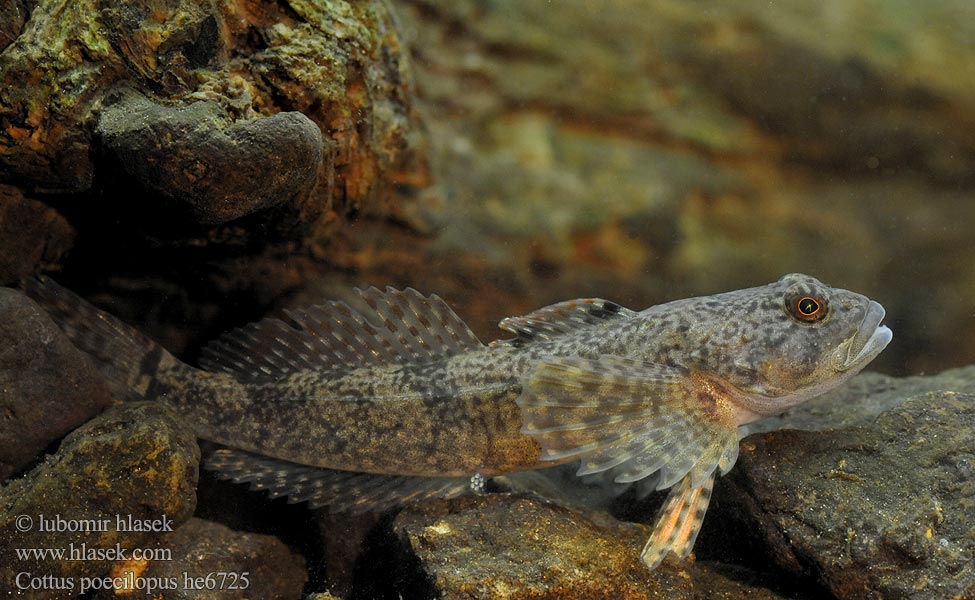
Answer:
[{"xmin": 366, "ymin": 494, "xmax": 792, "ymax": 600}]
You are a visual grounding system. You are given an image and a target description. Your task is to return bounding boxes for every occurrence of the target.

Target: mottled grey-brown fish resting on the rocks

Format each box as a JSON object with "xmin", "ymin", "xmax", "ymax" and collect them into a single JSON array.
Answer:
[{"xmin": 24, "ymin": 273, "xmax": 893, "ymax": 570}]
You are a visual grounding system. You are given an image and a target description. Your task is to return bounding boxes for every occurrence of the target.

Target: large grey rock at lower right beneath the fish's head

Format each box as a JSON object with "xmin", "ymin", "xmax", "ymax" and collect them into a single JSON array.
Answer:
[{"xmin": 709, "ymin": 390, "xmax": 975, "ymax": 599}]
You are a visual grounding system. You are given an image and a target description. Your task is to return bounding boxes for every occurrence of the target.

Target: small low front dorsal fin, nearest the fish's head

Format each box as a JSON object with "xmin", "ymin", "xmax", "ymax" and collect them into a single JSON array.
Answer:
[{"xmin": 495, "ymin": 298, "xmax": 637, "ymax": 345}]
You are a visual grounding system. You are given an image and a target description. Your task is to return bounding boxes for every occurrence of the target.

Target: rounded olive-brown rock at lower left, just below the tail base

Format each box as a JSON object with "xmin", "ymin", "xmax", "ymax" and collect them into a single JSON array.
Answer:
[{"xmin": 0, "ymin": 402, "xmax": 200, "ymax": 600}]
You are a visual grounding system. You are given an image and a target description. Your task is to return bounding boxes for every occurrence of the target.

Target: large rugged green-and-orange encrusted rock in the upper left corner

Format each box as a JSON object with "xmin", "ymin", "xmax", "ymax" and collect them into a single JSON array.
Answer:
[{"xmin": 0, "ymin": 0, "xmax": 430, "ymax": 223}]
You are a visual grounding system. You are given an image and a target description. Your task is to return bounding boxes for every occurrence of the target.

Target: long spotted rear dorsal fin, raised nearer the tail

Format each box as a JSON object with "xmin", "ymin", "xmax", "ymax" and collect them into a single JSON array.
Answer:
[{"xmin": 200, "ymin": 288, "xmax": 484, "ymax": 381}]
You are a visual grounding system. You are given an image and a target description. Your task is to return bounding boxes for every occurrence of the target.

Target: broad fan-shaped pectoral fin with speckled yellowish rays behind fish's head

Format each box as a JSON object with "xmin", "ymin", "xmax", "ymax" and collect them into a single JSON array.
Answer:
[{"xmin": 517, "ymin": 356, "xmax": 738, "ymax": 489}]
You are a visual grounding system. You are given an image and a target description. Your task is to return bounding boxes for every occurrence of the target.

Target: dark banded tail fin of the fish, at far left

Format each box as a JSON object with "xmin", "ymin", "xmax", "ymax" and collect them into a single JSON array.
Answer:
[{"xmin": 21, "ymin": 275, "xmax": 182, "ymax": 400}]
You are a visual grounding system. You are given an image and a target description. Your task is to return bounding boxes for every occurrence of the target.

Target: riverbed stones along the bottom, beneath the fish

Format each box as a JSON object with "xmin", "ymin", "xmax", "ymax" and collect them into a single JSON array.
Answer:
[{"xmin": 0, "ymin": 290, "xmax": 975, "ymax": 599}]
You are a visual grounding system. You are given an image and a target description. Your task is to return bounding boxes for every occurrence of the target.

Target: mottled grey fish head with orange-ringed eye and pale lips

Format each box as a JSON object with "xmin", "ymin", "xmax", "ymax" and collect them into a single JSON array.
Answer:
[{"xmin": 676, "ymin": 273, "xmax": 893, "ymax": 422}]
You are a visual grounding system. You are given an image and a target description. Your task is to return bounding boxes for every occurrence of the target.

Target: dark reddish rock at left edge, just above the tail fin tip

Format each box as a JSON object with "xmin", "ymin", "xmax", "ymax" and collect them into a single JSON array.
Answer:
[{"xmin": 0, "ymin": 184, "xmax": 74, "ymax": 284}]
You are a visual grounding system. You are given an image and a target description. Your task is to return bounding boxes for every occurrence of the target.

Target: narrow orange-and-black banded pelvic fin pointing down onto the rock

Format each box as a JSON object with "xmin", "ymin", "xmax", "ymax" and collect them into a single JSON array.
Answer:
[{"xmin": 640, "ymin": 472, "xmax": 715, "ymax": 571}]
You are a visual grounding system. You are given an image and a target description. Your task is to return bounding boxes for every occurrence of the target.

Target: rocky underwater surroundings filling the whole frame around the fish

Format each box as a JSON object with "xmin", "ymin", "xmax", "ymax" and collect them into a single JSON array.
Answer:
[{"xmin": 0, "ymin": 0, "xmax": 975, "ymax": 600}]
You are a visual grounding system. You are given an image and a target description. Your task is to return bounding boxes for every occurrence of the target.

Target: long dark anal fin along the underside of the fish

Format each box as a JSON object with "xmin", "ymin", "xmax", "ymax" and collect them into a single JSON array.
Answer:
[{"xmin": 205, "ymin": 448, "xmax": 470, "ymax": 513}]
